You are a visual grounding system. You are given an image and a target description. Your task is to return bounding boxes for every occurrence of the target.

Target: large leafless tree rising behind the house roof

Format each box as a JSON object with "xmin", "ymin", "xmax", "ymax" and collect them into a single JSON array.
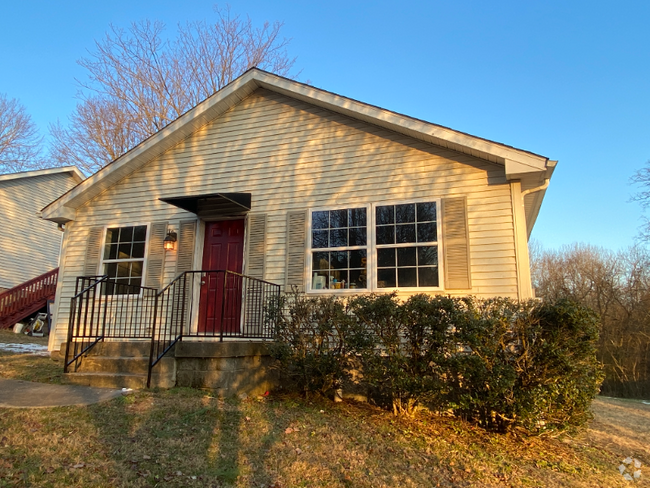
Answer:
[{"xmin": 50, "ymin": 7, "xmax": 295, "ymax": 173}]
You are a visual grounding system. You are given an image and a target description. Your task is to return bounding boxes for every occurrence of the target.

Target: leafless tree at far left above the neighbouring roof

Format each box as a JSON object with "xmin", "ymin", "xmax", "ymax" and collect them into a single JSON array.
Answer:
[{"xmin": 0, "ymin": 93, "xmax": 42, "ymax": 174}]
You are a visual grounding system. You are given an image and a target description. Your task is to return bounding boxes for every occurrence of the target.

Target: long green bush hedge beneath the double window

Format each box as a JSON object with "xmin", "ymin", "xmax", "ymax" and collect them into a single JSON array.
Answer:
[{"xmin": 272, "ymin": 294, "xmax": 603, "ymax": 432}]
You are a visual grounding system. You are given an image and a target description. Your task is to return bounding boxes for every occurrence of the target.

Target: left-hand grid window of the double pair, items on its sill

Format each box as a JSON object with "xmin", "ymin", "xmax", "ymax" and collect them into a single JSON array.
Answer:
[{"xmin": 310, "ymin": 208, "xmax": 368, "ymax": 290}]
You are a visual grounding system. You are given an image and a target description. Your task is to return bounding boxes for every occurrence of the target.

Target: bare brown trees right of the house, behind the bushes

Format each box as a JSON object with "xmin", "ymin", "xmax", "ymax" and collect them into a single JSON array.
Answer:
[{"xmin": 531, "ymin": 244, "xmax": 650, "ymax": 398}]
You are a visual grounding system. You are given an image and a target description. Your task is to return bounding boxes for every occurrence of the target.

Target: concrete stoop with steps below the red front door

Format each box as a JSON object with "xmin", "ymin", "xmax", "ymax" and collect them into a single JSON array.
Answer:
[{"xmin": 62, "ymin": 341, "xmax": 278, "ymax": 396}]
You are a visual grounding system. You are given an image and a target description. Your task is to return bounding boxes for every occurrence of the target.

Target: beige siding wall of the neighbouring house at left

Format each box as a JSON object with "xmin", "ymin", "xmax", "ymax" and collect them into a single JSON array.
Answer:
[{"xmin": 0, "ymin": 173, "xmax": 76, "ymax": 288}]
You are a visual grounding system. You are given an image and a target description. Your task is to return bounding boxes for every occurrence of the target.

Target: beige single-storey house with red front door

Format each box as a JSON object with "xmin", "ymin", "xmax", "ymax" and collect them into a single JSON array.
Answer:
[{"xmin": 42, "ymin": 69, "xmax": 556, "ymax": 385}]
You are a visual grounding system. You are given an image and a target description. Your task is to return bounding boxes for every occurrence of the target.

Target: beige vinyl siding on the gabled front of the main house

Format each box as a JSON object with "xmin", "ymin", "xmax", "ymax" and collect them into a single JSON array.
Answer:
[{"xmin": 49, "ymin": 90, "xmax": 517, "ymax": 346}]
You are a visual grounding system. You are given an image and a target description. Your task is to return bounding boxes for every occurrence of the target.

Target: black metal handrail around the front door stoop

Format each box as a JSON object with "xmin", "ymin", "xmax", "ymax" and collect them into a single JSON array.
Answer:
[{"xmin": 64, "ymin": 270, "xmax": 280, "ymax": 386}]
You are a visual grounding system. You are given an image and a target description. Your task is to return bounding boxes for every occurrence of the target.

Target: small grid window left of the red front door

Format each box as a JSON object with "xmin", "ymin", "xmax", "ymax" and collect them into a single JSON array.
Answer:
[{"xmin": 103, "ymin": 225, "xmax": 147, "ymax": 295}]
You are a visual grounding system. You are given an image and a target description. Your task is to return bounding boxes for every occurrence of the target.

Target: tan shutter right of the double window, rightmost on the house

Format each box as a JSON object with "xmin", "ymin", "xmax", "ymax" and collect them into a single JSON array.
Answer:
[{"xmin": 442, "ymin": 197, "xmax": 472, "ymax": 290}]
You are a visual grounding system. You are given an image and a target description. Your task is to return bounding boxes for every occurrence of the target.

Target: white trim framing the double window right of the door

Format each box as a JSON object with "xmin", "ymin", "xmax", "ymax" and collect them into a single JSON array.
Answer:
[{"xmin": 305, "ymin": 198, "xmax": 444, "ymax": 295}]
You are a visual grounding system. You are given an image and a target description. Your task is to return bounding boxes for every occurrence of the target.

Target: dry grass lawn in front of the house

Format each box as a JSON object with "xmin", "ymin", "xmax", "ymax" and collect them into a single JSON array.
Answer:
[{"xmin": 0, "ymin": 330, "xmax": 650, "ymax": 488}]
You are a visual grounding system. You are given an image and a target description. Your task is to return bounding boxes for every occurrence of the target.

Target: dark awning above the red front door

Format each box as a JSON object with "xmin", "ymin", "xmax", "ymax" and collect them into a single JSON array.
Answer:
[{"xmin": 160, "ymin": 193, "xmax": 251, "ymax": 219}]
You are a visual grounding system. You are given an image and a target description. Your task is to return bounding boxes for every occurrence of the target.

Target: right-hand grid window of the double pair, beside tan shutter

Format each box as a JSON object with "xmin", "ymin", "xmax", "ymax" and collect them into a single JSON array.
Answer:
[{"xmin": 375, "ymin": 202, "xmax": 439, "ymax": 288}]
